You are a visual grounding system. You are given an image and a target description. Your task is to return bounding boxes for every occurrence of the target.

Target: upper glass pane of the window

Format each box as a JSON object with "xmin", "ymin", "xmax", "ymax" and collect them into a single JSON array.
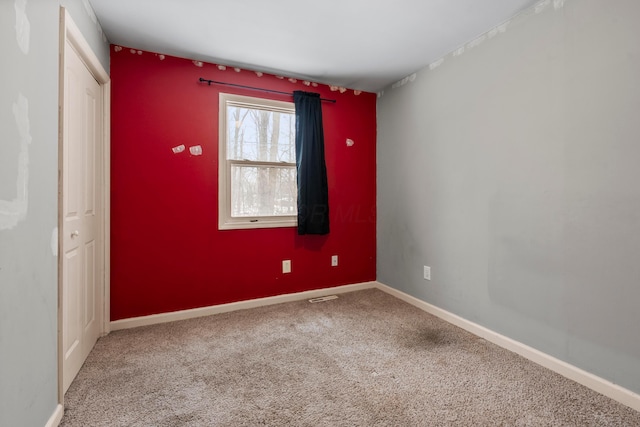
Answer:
[{"xmin": 227, "ymin": 106, "xmax": 296, "ymax": 163}]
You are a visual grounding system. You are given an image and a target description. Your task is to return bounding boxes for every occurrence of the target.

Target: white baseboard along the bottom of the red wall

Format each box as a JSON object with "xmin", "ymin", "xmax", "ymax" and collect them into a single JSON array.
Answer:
[{"xmin": 110, "ymin": 282, "xmax": 376, "ymax": 331}]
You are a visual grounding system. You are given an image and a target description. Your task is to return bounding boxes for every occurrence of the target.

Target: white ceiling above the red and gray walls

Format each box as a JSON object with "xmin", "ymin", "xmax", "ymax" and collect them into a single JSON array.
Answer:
[{"xmin": 89, "ymin": 0, "xmax": 539, "ymax": 92}]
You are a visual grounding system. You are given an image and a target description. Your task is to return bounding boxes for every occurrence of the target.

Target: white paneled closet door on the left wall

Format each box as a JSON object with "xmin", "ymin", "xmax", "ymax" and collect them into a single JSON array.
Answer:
[{"xmin": 61, "ymin": 42, "xmax": 104, "ymax": 392}]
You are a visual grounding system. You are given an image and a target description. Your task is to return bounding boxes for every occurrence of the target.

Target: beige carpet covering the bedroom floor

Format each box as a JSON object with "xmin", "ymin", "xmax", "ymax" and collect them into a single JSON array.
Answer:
[{"xmin": 62, "ymin": 289, "xmax": 640, "ymax": 426}]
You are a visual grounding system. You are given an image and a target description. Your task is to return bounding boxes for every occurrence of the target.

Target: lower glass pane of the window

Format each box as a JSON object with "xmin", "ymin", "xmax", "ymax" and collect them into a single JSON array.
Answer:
[{"xmin": 231, "ymin": 165, "xmax": 297, "ymax": 217}]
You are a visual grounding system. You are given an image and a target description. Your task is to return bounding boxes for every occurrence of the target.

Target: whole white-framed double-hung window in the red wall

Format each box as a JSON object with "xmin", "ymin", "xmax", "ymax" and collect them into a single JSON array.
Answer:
[{"xmin": 218, "ymin": 93, "xmax": 297, "ymax": 230}]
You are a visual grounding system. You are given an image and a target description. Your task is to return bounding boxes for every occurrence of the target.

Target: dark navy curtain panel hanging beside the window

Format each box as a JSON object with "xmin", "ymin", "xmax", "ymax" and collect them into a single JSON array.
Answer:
[{"xmin": 293, "ymin": 91, "xmax": 329, "ymax": 234}]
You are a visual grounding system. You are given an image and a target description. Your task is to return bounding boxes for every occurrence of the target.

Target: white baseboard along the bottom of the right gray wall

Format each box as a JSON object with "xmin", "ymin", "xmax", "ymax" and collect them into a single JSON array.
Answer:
[{"xmin": 375, "ymin": 282, "xmax": 640, "ymax": 411}]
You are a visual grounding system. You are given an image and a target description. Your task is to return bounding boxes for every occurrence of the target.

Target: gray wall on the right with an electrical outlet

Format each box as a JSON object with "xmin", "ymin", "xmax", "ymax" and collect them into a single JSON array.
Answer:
[{"xmin": 377, "ymin": 0, "xmax": 640, "ymax": 393}]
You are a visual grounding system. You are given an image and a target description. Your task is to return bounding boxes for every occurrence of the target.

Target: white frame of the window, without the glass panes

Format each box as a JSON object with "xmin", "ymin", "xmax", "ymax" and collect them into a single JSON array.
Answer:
[{"xmin": 218, "ymin": 93, "xmax": 298, "ymax": 230}]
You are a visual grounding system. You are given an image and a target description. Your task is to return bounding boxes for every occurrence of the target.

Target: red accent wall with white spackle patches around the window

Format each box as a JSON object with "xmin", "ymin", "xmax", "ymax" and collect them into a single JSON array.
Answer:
[{"xmin": 111, "ymin": 46, "xmax": 376, "ymax": 320}]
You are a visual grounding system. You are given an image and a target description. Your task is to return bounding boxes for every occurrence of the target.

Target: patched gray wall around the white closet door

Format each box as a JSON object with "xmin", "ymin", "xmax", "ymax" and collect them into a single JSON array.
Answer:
[{"xmin": 0, "ymin": 0, "xmax": 109, "ymax": 426}]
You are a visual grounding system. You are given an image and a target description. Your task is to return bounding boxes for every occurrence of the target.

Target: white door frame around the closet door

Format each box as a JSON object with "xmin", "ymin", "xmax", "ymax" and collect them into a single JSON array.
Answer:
[{"xmin": 58, "ymin": 7, "xmax": 111, "ymax": 407}]
